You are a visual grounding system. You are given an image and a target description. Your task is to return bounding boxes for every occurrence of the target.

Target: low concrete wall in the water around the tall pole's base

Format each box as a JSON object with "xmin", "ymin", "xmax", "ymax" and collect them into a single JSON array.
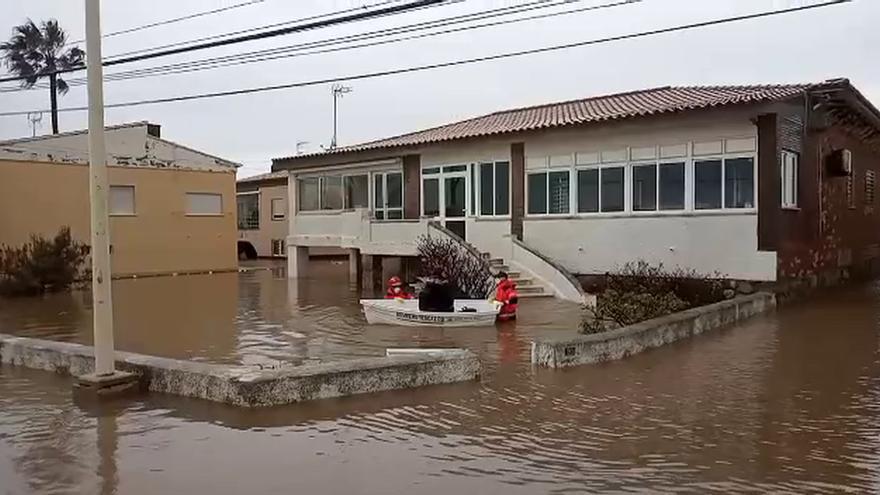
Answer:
[{"xmin": 0, "ymin": 334, "xmax": 480, "ymax": 407}]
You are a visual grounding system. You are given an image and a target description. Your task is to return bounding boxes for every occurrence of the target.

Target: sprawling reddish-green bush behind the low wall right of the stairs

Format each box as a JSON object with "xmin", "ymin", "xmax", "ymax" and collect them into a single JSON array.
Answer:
[{"xmin": 581, "ymin": 261, "xmax": 725, "ymax": 333}]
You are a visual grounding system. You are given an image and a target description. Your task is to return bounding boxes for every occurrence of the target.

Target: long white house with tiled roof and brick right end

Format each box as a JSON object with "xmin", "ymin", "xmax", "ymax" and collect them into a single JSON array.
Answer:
[{"xmin": 274, "ymin": 80, "xmax": 880, "ymax": 294}]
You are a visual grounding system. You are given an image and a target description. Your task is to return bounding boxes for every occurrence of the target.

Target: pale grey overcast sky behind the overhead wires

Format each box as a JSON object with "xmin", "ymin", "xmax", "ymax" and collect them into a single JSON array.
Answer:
[{"xmin": 0, "ymin": 0, "xmax": 880, "ymax": 176}]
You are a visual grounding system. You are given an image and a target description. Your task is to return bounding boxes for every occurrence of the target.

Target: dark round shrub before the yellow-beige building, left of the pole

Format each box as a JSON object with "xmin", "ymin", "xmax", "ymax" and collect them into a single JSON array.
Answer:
[{"xmin": 0, "ymin": 227, "xmax": 89, "ymax": 296}]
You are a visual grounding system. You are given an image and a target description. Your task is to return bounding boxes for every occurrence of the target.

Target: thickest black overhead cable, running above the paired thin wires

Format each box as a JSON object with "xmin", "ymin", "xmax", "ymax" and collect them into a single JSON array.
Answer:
[{"xmin": 0, "ymin": 0, "xmax": 461, "ymax": 82}]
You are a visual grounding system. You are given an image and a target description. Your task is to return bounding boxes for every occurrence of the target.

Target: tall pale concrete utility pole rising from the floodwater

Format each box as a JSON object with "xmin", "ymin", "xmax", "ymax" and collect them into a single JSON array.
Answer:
[{"xmin": 85, "ymin": 0, "xmax": 114, "ymax": 376}]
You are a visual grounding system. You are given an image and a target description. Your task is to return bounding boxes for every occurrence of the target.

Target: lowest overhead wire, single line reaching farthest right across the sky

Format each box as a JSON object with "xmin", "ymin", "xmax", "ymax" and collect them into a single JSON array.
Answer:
[{"xmin": 0, "ymin": 0, "xmax": 852, "ymax": 117}]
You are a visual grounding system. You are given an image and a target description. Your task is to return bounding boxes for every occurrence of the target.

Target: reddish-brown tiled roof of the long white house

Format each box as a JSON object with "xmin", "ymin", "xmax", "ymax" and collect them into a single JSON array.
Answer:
[{"xmin": 276, "ymin": 84, "xmax": 814, "ymax": 160}]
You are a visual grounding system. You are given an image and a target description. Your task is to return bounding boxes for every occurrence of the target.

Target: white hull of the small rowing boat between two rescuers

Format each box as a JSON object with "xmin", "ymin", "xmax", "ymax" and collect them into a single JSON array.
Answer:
[{"xmin": 361, "ymin": 299, "xmax": 500, "ymax": 327}]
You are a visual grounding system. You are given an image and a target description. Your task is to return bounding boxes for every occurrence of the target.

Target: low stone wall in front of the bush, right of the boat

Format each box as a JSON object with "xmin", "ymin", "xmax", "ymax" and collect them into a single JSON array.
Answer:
[{"xmin": 532, "ymin": 292, "xmax": 776, "ymax": 368}]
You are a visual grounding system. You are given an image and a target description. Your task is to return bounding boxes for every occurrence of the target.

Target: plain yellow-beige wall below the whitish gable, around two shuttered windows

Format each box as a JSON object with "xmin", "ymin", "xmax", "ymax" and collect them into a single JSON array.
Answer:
[{"xmin": 0, "ymin": 160, "xmax": 237, "ymax": 275}]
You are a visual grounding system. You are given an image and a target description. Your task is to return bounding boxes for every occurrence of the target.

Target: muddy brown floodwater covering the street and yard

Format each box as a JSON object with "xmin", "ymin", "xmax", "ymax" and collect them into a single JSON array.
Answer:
[{"xmin": 0, "ymin": 267, "xmax": 880, "ymax": 495}]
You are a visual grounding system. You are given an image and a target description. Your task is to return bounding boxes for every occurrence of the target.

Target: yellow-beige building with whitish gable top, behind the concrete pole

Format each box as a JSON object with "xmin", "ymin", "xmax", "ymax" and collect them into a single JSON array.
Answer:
[{"xmin": 0, "ymin": 122, "xmax": 238, "ymax": 276}]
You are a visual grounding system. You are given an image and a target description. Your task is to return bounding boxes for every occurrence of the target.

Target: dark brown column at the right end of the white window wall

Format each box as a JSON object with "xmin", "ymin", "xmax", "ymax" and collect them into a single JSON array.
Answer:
[{"xmin": 757, "ymin": 113, "xmax": 782, "ymax": 251}]
